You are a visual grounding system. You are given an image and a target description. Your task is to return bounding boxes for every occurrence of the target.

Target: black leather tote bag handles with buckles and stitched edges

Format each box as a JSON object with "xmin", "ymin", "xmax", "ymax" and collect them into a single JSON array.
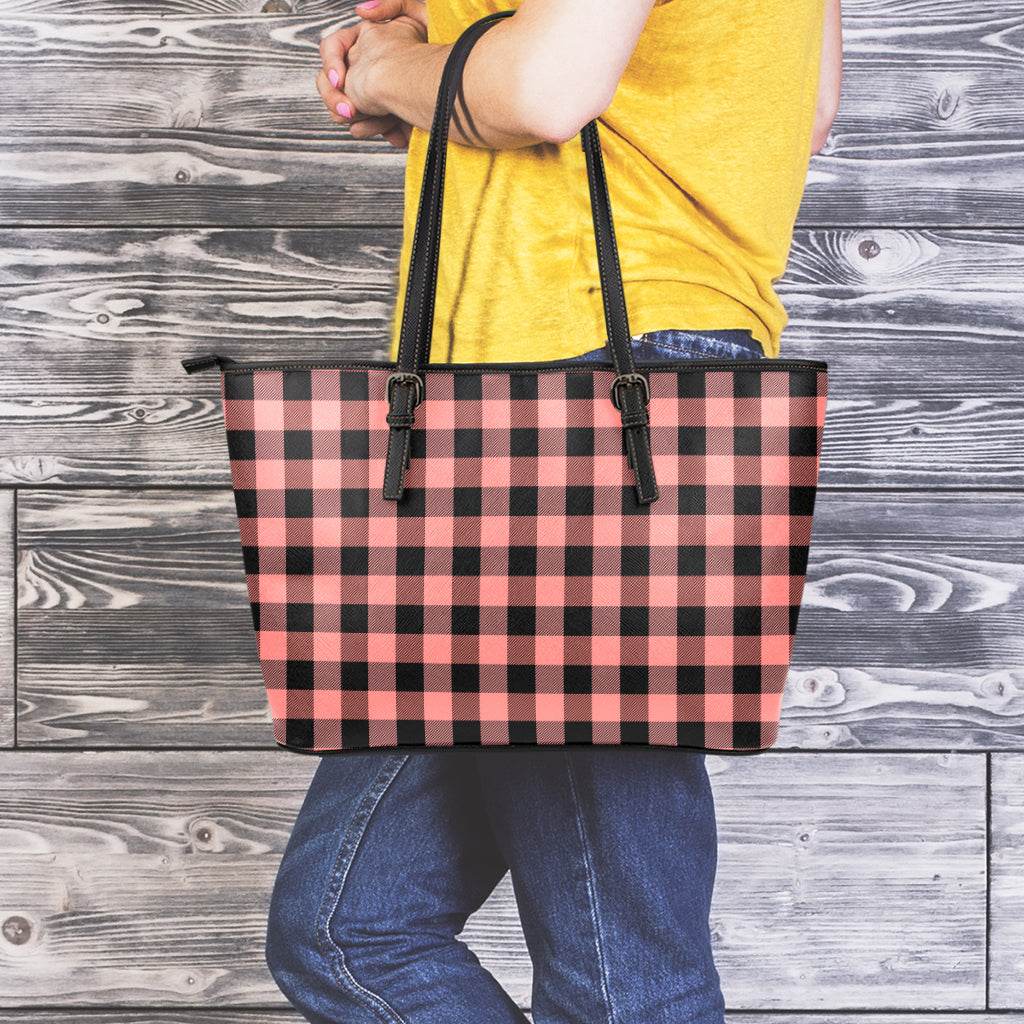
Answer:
[{"xmin": 384, "ymin": 10, "xmax": 657, "ymax": 504}]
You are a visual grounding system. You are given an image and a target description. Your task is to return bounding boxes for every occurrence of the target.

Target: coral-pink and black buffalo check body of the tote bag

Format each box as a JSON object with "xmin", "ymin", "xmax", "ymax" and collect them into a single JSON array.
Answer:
[{"xmin": 222, "ymin": 360, "xmax": 826, "ymax": 753}]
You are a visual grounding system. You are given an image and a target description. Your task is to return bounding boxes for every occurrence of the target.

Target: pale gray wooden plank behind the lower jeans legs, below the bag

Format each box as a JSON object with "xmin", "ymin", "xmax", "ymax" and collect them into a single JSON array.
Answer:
[{"xmin": 0, "ymin": 752, "xmax": 986, "ymax": 1010}]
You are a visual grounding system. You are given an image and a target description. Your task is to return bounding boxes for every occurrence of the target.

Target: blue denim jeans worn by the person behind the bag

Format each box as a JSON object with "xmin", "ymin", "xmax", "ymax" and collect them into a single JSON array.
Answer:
[{"xmin": 266, "ymin": 331, "xmax": 760, "ymax": 1024}]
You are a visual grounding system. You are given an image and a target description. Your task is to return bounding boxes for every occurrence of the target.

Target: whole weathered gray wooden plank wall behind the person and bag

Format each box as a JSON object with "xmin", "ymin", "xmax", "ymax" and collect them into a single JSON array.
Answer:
[{"xmin": 0, "ymin": 0, "xmax": 1024, "ymax": 1024}]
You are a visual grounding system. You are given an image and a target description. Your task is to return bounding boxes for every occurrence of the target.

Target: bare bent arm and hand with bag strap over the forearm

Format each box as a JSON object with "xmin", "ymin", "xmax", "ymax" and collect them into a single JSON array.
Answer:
[{"xmin": 316, "ymin": 0, "xmax": 654, "ymax": 150}]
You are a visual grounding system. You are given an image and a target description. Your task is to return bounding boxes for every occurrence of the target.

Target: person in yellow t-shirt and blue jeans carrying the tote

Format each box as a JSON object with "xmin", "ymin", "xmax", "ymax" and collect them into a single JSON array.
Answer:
[{"xmin": 266, "ymin": 0, "xmax": 842, "ymax": 1024}]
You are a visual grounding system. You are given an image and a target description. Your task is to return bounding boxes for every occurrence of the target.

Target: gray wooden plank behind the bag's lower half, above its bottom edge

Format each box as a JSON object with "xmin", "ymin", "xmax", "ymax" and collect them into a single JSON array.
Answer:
[{"xmin": 18, "ymin": 489, "xmax": 1024, "ymax": 750}]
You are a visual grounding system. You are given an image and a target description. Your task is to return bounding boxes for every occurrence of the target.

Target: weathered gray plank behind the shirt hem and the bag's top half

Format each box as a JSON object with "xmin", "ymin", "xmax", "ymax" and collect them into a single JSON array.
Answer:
[{"xmin": 0, "ymin": 229, "xmax": 1024, "ymax": 487}]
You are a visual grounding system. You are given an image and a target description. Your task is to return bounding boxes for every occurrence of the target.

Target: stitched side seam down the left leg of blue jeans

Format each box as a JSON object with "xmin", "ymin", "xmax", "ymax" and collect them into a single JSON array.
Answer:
[{"xmin": 316, "ymin": 754, "xmax": 411, "ymax": 1024}]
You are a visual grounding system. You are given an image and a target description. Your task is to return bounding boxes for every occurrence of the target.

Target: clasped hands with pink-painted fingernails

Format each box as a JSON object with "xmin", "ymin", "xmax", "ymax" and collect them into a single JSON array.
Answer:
[{"xmin": 316, "ymin": 0, "xmax": 427, "ymax": 148}]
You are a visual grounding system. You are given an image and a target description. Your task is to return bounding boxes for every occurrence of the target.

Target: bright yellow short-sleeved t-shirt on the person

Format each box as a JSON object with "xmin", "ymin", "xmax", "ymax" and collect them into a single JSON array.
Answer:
[{"xmin": 391, "ymin": 0, "xmax": 824, "ymax": 362}]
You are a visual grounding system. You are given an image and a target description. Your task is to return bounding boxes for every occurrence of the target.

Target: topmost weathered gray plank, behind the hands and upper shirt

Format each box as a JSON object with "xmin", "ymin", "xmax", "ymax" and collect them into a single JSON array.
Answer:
[{"xmin": 0, "ymin": 0, "xmax": 1024, "ymax": 227}]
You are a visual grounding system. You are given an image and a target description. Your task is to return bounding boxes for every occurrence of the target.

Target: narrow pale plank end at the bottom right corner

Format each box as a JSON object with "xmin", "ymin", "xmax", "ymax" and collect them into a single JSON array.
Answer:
[{"xmin": 988, "ymin": 753, "xmax": 1024, "ymax": 1010}]
